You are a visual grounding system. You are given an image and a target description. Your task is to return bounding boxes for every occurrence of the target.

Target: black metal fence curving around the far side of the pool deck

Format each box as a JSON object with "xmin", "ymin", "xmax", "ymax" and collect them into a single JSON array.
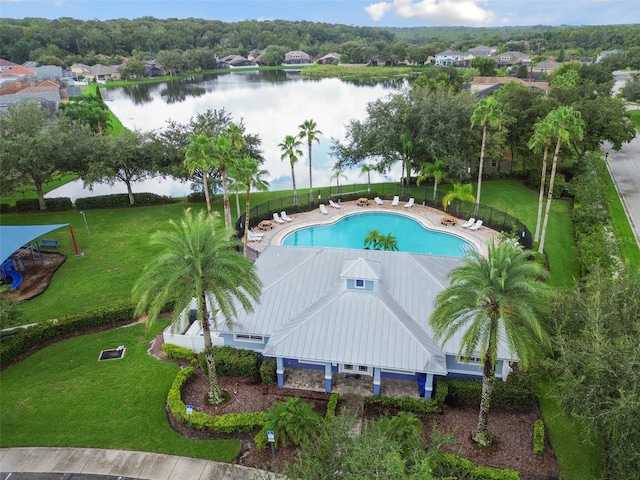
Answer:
[{"xmin": 236, "ymin": 183, "xmax": 533, "ymax": 249}]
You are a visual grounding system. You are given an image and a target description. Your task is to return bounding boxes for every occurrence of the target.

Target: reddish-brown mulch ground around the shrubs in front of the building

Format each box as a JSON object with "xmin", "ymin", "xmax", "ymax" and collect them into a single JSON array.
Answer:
[{"xmin": 150, "ymin": 334, "xmax": 560, "ymax": 480}]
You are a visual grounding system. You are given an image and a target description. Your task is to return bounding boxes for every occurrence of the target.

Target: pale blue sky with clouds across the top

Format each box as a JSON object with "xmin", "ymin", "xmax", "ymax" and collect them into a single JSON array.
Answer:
[{"xmin": 0, "ymin": 0, "xmax": 640, "ymax": 27}]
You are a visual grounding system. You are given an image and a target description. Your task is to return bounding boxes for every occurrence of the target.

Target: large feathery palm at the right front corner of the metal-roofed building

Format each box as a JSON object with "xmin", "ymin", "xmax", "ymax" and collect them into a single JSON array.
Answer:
[{"xmin": 429, "ymin": 242, "xmax": 551, "ymax": 446}]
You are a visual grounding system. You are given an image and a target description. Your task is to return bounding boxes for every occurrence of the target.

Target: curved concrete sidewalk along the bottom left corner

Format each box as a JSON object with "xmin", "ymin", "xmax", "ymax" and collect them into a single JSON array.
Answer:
[{"xmin": 0, "ymin": 447, "xmax": 277, "ymax": 480}]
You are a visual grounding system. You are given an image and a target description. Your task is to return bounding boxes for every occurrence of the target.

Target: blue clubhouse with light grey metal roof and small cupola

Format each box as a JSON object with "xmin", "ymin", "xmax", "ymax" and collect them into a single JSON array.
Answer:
[{"xmin": 164, "ymin": 245, "xmax": 513, "ymax": 397}]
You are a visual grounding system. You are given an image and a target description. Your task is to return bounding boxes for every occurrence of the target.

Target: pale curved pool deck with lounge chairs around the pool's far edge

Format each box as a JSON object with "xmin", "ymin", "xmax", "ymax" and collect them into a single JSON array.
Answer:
[{"xmin": 247, "ymin": 200, "xmax": 499, "ymax": 256}]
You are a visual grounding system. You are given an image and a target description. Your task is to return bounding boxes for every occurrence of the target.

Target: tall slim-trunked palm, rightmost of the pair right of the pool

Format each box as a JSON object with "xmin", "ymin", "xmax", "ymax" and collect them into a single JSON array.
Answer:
[{"xmin": 538, "ymin": 107, "xmax": 585, "ymax": 253}]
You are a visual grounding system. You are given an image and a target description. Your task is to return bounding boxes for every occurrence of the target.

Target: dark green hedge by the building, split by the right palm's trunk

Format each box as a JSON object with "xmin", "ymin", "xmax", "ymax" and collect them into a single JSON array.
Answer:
[{"xmin": 436, "ymin": 372, "xmax": 536, "ymax": 405}]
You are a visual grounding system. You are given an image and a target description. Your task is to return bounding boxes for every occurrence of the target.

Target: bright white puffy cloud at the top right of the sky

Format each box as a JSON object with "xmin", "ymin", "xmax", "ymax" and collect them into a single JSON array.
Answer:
[{"xmin": 365, "ymin": 0, "xmax": 495, "ymax": 25}]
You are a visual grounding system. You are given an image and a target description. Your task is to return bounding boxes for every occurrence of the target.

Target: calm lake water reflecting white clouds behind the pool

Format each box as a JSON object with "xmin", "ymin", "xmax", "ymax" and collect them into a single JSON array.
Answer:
[{"xmin": 47, "ymin": 71, "xmax": 406, "ymax": 200}]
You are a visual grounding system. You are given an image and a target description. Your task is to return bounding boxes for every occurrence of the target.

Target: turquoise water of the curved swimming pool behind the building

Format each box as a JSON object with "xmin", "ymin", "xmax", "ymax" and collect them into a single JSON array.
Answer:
[{"xmin": 282, "ymin": 213, "xmax": 474, "ymax": 257}]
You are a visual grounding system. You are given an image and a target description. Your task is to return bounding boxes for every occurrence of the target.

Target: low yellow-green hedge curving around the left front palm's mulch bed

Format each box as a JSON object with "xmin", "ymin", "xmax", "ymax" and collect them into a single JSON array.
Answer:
[{"xmin": 167, "ymin": 367, "xmax": 266, "ymax": 435}]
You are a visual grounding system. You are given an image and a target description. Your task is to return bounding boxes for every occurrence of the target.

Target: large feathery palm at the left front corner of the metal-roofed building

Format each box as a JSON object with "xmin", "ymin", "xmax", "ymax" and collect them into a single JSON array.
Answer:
[{"xmin": 133, "ymin": 209, "xmax": 262, "ymax": 404}]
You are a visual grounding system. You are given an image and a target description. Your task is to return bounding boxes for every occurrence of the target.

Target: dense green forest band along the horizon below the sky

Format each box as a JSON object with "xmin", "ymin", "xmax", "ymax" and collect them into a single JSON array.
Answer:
[{"xmin": 0, "ymin": 17, "xmax": 640, "ymax": 68}]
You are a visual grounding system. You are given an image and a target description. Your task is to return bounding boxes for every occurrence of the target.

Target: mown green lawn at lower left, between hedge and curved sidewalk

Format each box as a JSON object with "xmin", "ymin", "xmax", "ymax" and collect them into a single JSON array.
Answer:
[{"xmin": 0, "ymin": 323, "xmax": 241, "ymax": 462}]
